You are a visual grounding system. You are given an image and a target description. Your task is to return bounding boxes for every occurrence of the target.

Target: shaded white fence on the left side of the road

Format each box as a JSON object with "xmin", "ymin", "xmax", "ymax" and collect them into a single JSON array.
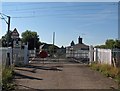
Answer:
[{"xmin": 0, "ymin": 45, "xmax": 29, "ymax": 65}]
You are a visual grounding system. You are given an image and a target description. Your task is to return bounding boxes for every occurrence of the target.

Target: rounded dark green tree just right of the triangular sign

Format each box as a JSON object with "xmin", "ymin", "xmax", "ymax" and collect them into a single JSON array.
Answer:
[{"xmin": 22, "ymin": 30, "xmax": 40, "ymax": 50}]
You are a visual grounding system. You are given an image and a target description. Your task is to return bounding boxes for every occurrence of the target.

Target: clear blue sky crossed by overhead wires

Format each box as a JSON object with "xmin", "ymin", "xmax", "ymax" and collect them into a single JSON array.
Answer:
[{"xmin": 0, "ymin": 2, "xmax": 118, "ymax": 47}]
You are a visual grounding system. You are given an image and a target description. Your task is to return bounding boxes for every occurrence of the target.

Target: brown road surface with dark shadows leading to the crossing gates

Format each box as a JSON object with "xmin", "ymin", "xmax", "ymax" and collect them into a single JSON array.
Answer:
[{"xmin": 15, "ymin": 64, "xmax": 118, "ymax": 89}]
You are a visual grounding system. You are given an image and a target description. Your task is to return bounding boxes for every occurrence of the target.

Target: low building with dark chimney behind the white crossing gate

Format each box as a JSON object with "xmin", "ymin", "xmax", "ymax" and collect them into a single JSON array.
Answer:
[{"xmin": 66, "ymin": 36, "xmax": 89, "ymax": 59}]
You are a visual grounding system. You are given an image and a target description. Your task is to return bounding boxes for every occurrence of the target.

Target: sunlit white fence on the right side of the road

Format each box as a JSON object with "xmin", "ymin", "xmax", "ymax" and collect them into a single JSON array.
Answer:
[{"xmin": 89, "ymin": 46, "xmax": 120, "ymax": 65}]
